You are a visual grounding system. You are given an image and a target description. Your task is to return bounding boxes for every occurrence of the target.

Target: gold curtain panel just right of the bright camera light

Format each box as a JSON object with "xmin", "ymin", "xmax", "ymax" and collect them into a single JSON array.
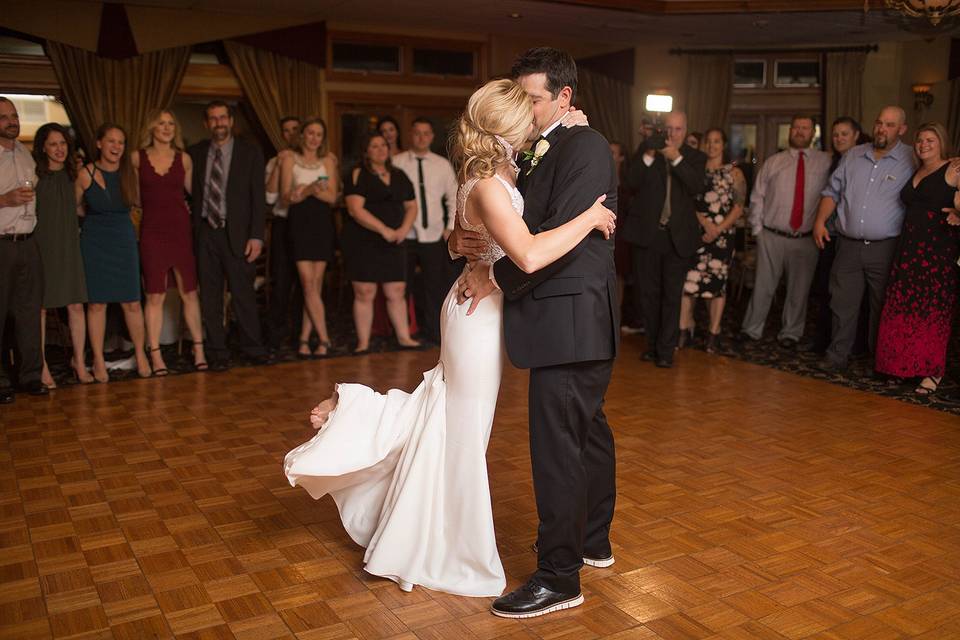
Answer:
[{"xmin": 684, "ymin": 54, "xmax": 733, "ymax": 133}]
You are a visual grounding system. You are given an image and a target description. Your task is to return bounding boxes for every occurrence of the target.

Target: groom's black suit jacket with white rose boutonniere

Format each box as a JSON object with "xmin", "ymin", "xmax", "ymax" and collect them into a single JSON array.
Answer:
[{"xmin": 494, "ymin": 126, "xmax": 620, "ymax": 369}]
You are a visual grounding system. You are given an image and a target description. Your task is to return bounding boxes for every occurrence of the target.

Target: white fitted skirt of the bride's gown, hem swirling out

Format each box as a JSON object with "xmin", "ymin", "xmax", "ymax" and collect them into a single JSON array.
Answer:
[{"xmin": 284, "ymin": 284, "xmax": 506, "ymax": 596}]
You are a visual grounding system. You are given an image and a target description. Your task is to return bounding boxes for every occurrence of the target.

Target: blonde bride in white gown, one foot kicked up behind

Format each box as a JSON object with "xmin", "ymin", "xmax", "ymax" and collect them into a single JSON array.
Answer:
[{"xmin": 284, "ymin": 80, "xmax": 616, "ymax": 596}]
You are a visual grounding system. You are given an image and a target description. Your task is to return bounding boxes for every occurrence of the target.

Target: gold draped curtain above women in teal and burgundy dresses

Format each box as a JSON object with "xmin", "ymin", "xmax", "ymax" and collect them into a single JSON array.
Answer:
[{"xmin": 47, "ymin": 40, "xmax": 190, "ymax": 152}]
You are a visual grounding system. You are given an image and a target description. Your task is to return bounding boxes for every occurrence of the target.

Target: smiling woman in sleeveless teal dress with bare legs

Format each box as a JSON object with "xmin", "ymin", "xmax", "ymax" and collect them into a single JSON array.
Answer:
[{"xmin": 76, "ymin": 124, "xmax": 151, "ymax": 382}]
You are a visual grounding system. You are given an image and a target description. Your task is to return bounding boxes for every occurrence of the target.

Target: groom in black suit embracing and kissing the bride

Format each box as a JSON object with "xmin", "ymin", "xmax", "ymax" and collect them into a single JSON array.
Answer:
[{"xmin": 450, "ymin": 47, "xmax": 620, "ymax": 618}]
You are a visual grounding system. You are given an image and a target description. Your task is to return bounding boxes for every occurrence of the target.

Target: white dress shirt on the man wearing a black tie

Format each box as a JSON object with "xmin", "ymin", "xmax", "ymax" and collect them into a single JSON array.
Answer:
[{"xmin": 392, "ymin": 151, "xmax": 457, "ymax": 242}]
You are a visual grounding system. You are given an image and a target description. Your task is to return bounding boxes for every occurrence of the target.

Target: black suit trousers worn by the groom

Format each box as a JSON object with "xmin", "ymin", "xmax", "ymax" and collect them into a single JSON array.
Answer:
[{"xmin": 530, "ymin": 360, "xmax": 616, "ymax": 593}]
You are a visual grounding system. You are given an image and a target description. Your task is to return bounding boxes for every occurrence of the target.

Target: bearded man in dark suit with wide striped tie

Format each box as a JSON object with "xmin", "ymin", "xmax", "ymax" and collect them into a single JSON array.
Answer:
[{"xmin": 188, "ymin": 101, "xmax": 268, "ymax": 370}]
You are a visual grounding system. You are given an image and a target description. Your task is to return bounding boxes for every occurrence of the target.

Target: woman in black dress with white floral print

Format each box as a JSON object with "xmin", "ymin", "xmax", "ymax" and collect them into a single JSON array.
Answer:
[{"xmin": 679, "ymin": 128, "xmax": 747, "ymax": 353}]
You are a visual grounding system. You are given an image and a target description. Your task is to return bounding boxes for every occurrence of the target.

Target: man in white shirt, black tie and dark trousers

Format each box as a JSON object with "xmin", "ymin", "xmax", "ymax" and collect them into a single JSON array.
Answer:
[{"xmin": 393, "ymin": 118, "xmax": 458, "ymax": 344}]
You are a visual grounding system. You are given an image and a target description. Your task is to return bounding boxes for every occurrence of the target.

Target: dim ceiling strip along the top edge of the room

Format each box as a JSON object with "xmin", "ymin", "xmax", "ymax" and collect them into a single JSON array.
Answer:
[{"xmin": 101, "ymin": 0, "xmax": 960, "ymax": 47}]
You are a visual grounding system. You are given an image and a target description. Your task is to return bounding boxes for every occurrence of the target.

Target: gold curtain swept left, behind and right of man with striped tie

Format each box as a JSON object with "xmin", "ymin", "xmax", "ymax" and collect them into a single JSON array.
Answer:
[{"xmin": 223, "ymin": 40, "xmax": 323, "ymax": 150}]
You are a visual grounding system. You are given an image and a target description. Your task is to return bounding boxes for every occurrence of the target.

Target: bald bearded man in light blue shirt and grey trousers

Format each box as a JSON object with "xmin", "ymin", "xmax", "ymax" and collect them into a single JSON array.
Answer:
[{"xmin": 813, "ymin": 106, "xmax": 914, "ymax": 370}]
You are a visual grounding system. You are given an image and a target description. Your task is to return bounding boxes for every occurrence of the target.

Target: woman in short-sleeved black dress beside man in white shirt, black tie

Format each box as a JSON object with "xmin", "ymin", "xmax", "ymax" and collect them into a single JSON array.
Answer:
[{"xmin": 343, "ymin": 133, "xmax": 420, "ymax": 353}]
